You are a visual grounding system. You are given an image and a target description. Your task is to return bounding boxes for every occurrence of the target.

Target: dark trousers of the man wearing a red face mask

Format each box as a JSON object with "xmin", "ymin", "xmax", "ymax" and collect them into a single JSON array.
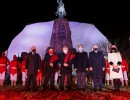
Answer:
[{"xmin": 43, "ymin": 70, "xmax": 55, "ymax": 88}]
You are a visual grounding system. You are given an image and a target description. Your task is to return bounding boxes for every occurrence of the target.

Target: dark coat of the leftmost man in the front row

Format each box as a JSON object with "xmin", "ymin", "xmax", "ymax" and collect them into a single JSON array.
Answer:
[{"xmin": 25, "ymin": 52, "xmax": 41, "ymax": 75}]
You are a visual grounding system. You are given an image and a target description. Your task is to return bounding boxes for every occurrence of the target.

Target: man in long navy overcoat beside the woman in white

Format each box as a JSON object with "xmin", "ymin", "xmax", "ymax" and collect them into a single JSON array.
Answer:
[{"xmin": 89, "ymin": 45, "xmax": 105, "ymax": 91}]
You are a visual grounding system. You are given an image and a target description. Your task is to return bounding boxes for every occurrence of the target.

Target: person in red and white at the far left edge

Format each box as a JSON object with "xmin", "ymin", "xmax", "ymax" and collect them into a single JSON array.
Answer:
[{"xmin": 0, "ymin": 52, "xmax": 10, "ymax": 86}]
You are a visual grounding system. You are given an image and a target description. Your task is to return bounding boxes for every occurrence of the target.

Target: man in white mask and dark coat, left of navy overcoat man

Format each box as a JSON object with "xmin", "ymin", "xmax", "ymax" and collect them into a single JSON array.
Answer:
[{"xmin": 74, "ymin": 44, "xmax": 89, "ymax": 91}]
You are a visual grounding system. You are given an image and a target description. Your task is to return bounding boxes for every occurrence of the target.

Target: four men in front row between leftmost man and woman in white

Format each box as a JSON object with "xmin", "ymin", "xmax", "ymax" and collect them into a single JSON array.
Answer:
[{"xmin": 40, "ymin": 45, "xmax": 105, "ymax": 90}]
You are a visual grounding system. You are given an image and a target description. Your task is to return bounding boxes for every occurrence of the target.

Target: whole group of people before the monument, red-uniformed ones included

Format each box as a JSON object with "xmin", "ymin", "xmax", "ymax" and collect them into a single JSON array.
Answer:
[{"xmin": 0, "ymin": 44, "xmax": 128, "ymax": 91}]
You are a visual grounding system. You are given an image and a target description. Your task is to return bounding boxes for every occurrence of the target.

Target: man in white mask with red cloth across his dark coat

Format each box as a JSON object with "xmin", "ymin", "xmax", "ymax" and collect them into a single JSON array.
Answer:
[{"xmin": 59, "ymin": 46, "xmax": 75, "ymax": 90}]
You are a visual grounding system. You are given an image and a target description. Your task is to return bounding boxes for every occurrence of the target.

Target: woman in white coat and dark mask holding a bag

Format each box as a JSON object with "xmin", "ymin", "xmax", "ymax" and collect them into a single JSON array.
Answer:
[{"xmin": 108, "ymin": 45, "xmax": 123, "ymax": 91}]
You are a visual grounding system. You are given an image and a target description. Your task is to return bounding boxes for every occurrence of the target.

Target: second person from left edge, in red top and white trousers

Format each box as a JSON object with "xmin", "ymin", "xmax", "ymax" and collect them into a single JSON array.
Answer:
[{"xmin": 9, "ymin": 55, "xmax": 20, "ymax": 86}]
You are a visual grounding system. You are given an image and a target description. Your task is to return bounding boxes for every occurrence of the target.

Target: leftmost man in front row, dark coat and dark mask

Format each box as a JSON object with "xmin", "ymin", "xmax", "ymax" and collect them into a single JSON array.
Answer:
[{"xmin": 25, "ymin": 46, "xmax": 41, "ymax": 91}]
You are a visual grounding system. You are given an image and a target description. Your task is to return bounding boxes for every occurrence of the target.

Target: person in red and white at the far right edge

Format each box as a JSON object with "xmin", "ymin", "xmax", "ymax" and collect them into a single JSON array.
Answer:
[{"xmin": 121, "ymin": 58, "xmax": 129, "ymax": 86}]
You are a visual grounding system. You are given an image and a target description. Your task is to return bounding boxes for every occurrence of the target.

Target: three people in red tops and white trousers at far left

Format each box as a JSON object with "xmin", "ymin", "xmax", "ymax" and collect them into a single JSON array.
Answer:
[{"xmin": 0, "ymin": 52, "xmax": 25, "ymax": 86}]
